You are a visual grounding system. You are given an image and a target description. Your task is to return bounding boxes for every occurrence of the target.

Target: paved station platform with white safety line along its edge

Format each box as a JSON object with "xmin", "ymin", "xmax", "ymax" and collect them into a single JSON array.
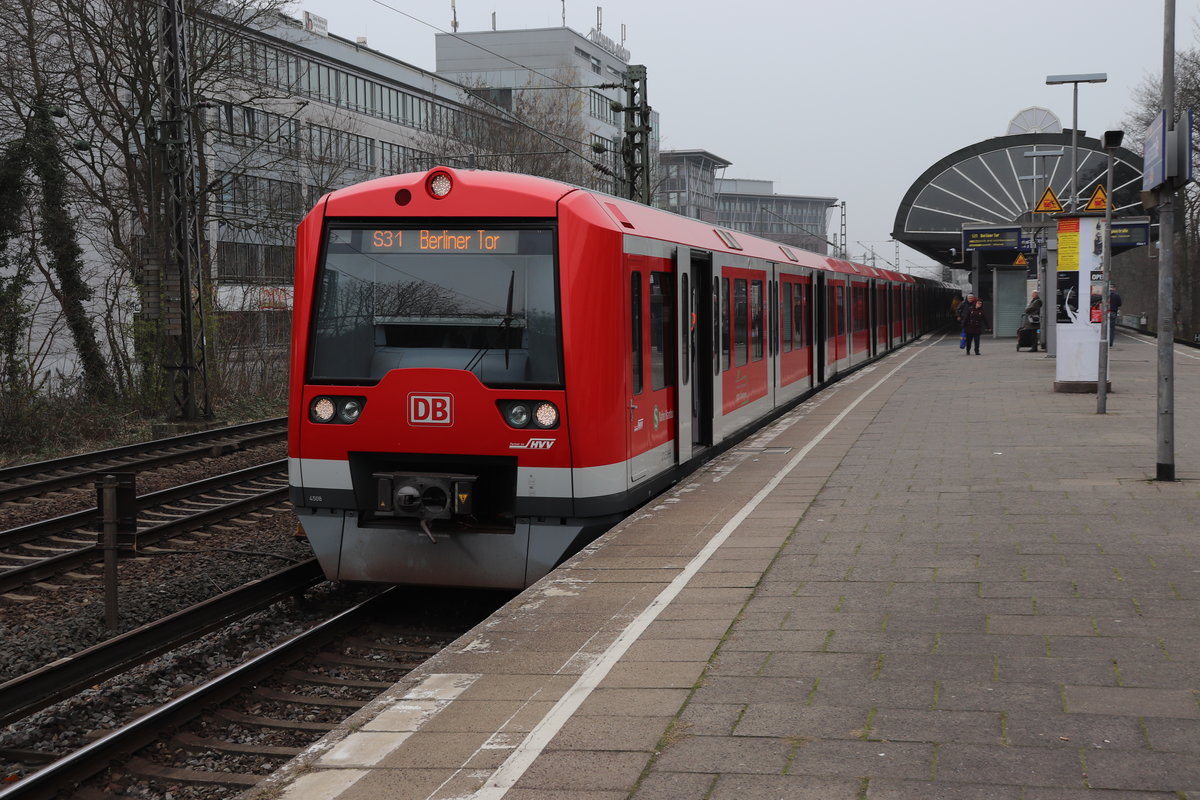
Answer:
[{"xmin": 255, "ymin": 333, "xmax": 1200, "ymax": 800}]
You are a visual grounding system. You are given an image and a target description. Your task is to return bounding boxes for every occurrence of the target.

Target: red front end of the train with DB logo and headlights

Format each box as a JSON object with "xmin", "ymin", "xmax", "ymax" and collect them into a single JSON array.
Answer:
[{"xmin": 289, "ymin": 170, "xmax": 643, "ymax": 587}]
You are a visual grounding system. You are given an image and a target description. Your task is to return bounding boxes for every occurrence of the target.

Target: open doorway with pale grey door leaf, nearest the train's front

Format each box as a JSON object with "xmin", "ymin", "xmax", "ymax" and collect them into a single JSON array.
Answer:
[{"xmin": 674, "ymin": 247, "xmax": 713, "ymax": 464}]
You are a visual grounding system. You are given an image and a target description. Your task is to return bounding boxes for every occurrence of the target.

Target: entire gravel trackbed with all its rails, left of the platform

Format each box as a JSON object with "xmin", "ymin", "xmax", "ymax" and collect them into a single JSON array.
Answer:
[{"xmin": 0, "ymin": 419, "xmax": 506, "ymax": 800}]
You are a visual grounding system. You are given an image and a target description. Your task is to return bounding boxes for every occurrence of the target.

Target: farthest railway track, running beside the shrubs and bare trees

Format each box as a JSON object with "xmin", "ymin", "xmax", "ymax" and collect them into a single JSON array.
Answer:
[{"xmin": 0, "ymin": 417, "xmax": 287, "ymax": 503}]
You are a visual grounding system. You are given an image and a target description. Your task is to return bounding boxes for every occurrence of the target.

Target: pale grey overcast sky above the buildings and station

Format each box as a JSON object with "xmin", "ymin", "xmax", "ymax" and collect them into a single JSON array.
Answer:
[{"xmin": 285, "ymin": 0, "xmax": 1200, "ymax": 277}]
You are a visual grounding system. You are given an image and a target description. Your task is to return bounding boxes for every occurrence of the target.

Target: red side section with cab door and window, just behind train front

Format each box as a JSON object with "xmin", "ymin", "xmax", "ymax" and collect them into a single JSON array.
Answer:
[{"xmin": 625, "ymin": 253, "xmax": 678, "ymax": 483}]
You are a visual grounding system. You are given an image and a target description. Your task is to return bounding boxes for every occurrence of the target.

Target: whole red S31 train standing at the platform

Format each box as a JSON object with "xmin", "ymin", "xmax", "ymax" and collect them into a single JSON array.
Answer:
[{"xmin": 288, "ymin": 168, "xmax": 952, "ymax": 588}]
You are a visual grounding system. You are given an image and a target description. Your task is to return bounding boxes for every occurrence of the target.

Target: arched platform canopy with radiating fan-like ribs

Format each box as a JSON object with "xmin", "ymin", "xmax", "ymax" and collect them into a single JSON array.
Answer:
[{"xmin": 892, "ymin": 130, "xmax": 1146, "ymax": 266}]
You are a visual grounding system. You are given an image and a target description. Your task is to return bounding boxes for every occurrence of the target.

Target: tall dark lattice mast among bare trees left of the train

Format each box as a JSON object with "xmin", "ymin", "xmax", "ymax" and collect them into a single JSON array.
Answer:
[{"xmin": 158, "ymin": 0, "xmax": 212, "ymax": 420}]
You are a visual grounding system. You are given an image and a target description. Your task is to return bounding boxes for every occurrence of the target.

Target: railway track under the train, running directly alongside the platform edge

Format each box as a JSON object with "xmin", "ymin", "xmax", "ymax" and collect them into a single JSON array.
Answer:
[{"xmin": 0, "ymin": 589, "xmax": 487, "ymax": 800}]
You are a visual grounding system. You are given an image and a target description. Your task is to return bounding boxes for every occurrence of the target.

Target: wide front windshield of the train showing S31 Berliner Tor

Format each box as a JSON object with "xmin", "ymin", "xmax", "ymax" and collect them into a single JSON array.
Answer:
[{"xmin": 308, "ymin": 225, "xmax": 562, "ymax": 386}]
